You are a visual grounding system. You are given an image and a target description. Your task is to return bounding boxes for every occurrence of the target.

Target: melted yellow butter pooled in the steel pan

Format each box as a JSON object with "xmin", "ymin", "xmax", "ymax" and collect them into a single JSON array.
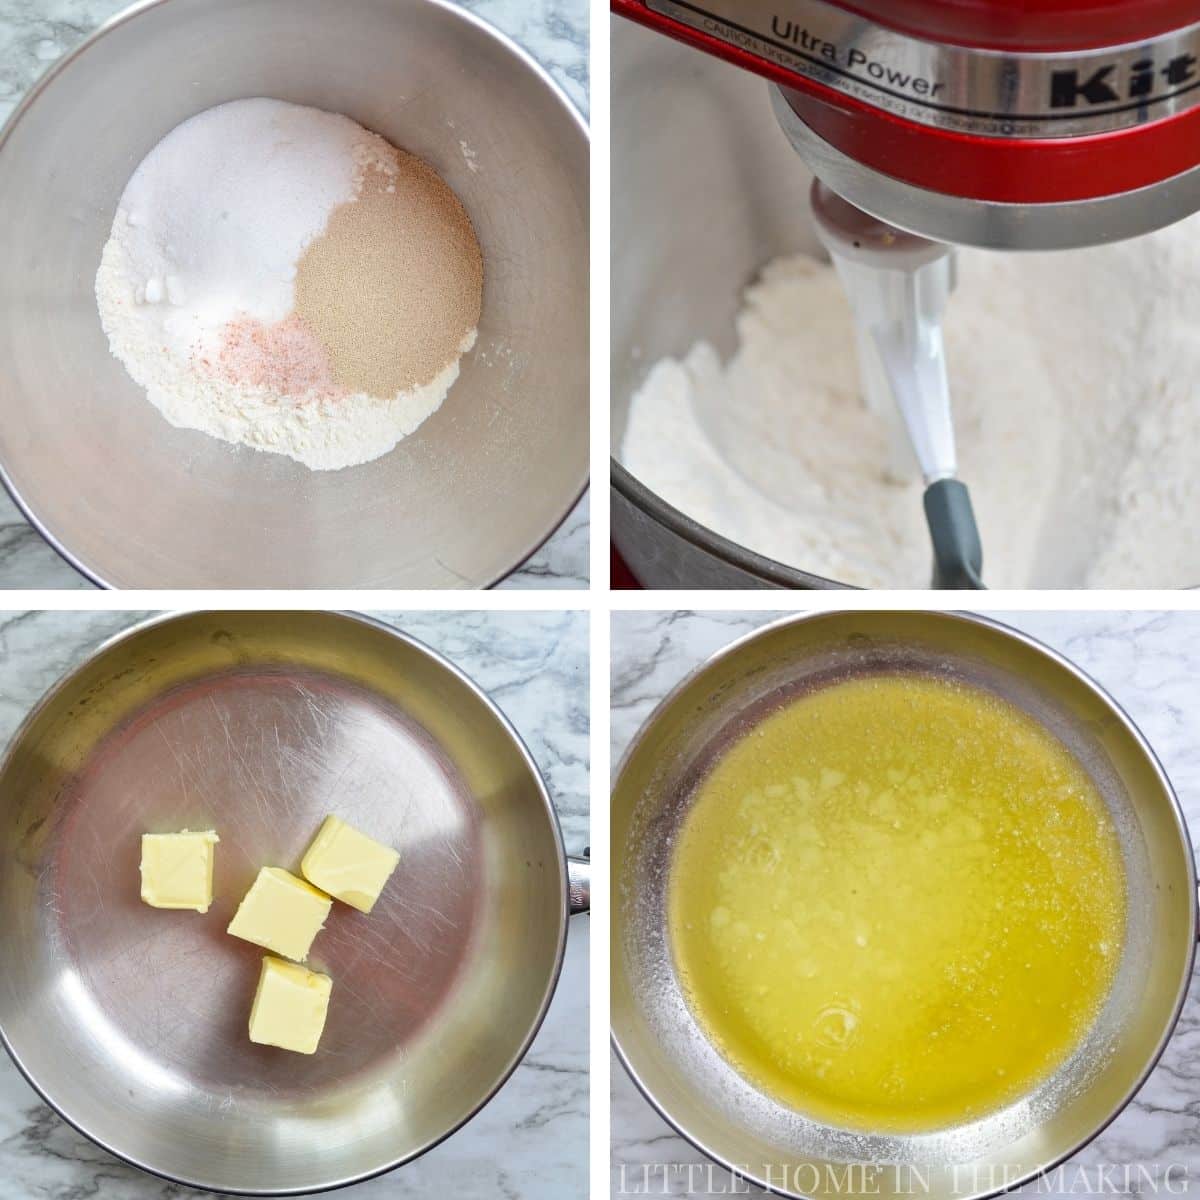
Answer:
[{"xmin": 668, "ymin": 674, "xmax": 1126, "ymax": 1133}]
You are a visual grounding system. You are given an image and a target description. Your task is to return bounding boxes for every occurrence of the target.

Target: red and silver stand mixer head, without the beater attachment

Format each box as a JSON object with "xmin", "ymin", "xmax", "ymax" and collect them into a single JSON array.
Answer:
[{"xmin": 612, "ymin": 0, "xmax": 1200, "ymax": 250}]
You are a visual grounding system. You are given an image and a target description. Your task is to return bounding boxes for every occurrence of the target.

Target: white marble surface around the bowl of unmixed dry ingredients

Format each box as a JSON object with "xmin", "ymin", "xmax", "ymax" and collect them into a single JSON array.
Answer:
[{"xmin": 0, "ymin": 0, "xmax": 588, "ymax": 589}]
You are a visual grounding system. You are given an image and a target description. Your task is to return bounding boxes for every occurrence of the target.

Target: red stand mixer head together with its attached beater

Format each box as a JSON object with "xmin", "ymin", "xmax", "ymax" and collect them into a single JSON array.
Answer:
[{"xmin": 612, "ymin": 0, "xmax": 1200, "ymax": 587}]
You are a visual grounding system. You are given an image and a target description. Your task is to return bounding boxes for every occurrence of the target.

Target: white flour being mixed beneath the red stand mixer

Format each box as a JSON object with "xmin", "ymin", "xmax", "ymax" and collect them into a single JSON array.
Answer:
[{"xmin": 622, "ymin": 218, "xmax": 1200, "ymax": 588}]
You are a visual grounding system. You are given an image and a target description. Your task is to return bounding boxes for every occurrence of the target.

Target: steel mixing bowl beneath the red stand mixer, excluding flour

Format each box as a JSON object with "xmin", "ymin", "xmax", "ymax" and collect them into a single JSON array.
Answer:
[{"xmin": 611, "ymin": 18, "xmax": 841, "ymax": 588}]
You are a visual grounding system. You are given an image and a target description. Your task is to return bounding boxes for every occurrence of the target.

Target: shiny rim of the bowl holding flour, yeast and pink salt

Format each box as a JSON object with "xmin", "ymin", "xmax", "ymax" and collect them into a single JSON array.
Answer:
[{"xmin": 0, "ymin": 0, "xmax": 592, "ymax": 590}]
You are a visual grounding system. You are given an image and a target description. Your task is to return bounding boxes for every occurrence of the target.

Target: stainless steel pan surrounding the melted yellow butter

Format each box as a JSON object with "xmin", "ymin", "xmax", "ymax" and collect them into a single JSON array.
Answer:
[{"xmin": 612, "ymin": 612, "xmax": 1196, "ymax": 1200}]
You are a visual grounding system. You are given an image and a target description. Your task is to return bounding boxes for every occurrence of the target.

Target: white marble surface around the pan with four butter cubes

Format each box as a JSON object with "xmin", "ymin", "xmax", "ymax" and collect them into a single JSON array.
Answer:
[{"xmin": 0, "ymin": 612, "xmax": 589, "ymax": 1200}]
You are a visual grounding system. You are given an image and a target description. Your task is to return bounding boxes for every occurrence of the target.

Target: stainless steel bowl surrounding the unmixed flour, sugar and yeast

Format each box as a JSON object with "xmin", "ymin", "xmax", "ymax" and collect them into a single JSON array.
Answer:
[{"xmin": 0, "ymin": 0, "xmax": 588, "ymax": 588}]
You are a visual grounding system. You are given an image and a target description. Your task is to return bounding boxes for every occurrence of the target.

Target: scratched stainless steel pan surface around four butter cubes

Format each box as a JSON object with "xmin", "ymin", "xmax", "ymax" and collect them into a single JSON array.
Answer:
[{"xmin": 0, "ymin": 612, "xmax": 568, "ymax": 1195}]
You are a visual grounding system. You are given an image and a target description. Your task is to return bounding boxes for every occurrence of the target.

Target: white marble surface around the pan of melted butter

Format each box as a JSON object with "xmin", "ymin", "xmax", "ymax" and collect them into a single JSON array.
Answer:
[{"xmin": 612, "ymin": 612, "xmax": 1200, "ymax": 1195}]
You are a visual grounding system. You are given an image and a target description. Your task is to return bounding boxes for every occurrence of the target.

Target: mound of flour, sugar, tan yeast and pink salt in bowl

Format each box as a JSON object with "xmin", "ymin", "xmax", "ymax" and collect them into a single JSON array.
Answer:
[{"xmin": 96, "ymin": 98, "xmax": 482, "ymax": 470}]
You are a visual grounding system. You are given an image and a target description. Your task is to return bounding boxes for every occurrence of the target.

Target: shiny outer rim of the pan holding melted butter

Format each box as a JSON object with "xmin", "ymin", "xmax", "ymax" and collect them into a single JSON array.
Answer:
[{"xmin": 610, "ymin": 608, "xmax": 1200, "ymax": 1200}]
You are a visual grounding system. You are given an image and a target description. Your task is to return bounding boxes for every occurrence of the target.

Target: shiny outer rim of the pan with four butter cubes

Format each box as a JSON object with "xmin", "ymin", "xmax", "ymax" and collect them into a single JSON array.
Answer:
[{"xmin": 0, "ymin": 614, "xmax": 570, "ymax": 1196}]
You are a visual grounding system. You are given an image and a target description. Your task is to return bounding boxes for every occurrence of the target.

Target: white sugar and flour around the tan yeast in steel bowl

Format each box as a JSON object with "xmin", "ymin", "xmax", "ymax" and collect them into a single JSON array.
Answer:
[{"xmin": 96, "ymin": 98, "xmax": 475, "ymax": 469}]
